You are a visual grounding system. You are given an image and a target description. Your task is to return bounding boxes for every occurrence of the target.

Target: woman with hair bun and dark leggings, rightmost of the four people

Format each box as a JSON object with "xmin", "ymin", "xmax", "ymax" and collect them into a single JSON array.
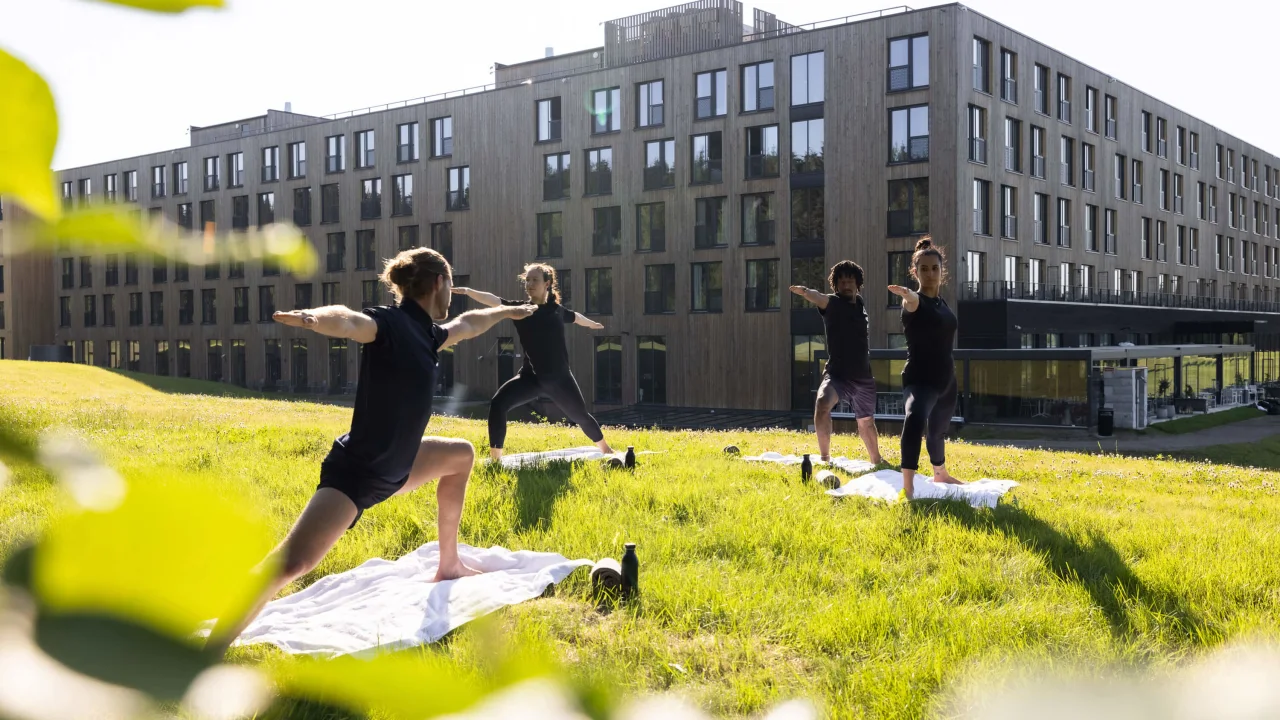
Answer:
[{"xmin": 888, "ymin": 237, "xmax": 963, "ymax": 498}]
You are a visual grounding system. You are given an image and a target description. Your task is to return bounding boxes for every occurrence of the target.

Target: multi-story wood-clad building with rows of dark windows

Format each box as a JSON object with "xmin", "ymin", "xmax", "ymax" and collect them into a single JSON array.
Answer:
[{"xmin": 45, "ymin": 0, "xmax": 1280, "ymax": 410}]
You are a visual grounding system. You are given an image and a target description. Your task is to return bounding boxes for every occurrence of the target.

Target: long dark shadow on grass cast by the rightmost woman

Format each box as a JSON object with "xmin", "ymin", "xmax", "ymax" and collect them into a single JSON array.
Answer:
[{"xmin": 911, "ymin": 501, "xmax": 1206, "ymax": 642}]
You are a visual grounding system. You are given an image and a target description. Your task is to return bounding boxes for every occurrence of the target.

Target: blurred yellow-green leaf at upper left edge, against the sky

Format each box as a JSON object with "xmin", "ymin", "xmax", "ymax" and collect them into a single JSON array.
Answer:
[{"xmin": 0, "ymin": 50, "xmax": 60, "ymax": 219}]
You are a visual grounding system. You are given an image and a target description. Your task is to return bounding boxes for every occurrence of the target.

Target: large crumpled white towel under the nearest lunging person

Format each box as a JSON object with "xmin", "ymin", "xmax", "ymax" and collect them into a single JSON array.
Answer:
[{"xmin": 236, "ymin": 542, "xmax": 591, "ymax": 657}]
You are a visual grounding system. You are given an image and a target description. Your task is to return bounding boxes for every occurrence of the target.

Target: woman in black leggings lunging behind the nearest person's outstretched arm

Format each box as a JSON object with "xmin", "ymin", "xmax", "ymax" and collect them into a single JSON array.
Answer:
[{"xmin": 453, "ymin": 263, "xmax": 613, "ymax": 460}]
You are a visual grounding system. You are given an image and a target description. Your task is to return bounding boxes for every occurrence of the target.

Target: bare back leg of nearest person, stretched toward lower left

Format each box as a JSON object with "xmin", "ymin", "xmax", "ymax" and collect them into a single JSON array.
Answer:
[{"xmin": 206, "ymin": 488, "xmax": 356, "ymax": 653}]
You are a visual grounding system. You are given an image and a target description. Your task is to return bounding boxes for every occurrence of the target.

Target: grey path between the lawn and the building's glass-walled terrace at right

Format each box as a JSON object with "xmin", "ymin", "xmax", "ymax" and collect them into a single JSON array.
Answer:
[{"xmin": 960, "ymin": 415, "xmax": 1280, "ymax": 454}]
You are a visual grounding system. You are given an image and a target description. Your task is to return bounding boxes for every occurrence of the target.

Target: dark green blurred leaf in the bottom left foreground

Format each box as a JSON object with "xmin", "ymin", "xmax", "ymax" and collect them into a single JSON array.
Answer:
[{"xmin": 35, "ymin": 611, "xmax": 218, "ymax": 701}]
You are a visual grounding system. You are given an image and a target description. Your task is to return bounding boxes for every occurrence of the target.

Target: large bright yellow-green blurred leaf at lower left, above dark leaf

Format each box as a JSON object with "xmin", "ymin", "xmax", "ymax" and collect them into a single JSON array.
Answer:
[{"xmin": 32, "ymin": 478, "xmax": 270, "ymax": 638}]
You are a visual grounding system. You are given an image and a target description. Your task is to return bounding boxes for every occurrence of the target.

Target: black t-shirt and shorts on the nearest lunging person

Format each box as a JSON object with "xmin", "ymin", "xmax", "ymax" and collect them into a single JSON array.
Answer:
[{"xmin": 329, "ymin": 300, "xmax": 449, "ymax": 483}]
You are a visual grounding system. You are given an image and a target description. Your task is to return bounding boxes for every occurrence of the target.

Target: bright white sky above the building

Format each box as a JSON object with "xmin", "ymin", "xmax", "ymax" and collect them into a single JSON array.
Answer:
[{"xmin": 0, "ymin": 0, "xmax": 1280, "ymax": 169}]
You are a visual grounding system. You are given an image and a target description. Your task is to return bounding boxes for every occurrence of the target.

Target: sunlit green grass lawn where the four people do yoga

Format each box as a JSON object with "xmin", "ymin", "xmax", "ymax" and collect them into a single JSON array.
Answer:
[{"xmin": 0, "ymin": 361, "xmax": 1280, "ymax": 717}]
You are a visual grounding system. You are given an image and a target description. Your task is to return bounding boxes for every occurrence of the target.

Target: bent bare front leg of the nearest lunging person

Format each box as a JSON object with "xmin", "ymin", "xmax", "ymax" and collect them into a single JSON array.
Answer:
[{"xmin": 396, "ymin": 437, "xmax": 480, "ymax": 583}]
